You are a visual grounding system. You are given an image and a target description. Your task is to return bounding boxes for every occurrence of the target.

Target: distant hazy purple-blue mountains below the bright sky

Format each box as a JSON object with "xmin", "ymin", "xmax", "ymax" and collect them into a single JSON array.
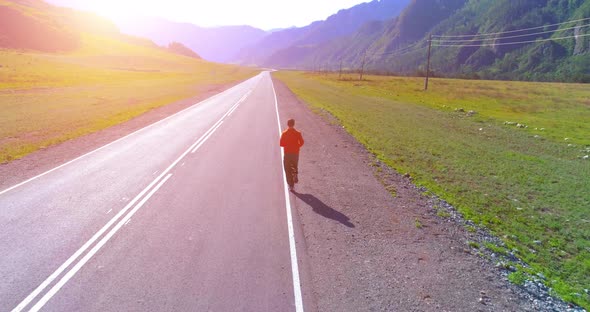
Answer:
[{"xmin": 108, "ymin": 0, "xmax": 409, "ymax": 65}]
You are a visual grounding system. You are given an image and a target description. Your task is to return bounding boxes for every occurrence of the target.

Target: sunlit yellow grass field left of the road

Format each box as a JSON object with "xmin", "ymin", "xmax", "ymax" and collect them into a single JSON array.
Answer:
[{"xmin": 0, "ymin": 34, "xmax": 257, "ymax": 163}]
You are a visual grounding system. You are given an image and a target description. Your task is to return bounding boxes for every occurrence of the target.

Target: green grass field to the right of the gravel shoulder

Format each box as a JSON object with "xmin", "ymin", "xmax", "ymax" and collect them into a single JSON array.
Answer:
[{"xmin": 274, "ymin": 72, "xmax": 590, "ymax": 309}]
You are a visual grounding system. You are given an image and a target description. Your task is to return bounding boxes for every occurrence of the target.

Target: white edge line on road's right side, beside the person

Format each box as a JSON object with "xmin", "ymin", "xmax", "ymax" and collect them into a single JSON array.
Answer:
[{"xmin": 268, "ymin": 73, "xmax": 303, "ymax": 312}]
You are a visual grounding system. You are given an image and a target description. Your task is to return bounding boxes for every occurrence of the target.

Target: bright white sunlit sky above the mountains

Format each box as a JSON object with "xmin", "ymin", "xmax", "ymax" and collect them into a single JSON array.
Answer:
[{"xmin": 46, "ymin": 0, "xmax": 370, "ymax": 30}]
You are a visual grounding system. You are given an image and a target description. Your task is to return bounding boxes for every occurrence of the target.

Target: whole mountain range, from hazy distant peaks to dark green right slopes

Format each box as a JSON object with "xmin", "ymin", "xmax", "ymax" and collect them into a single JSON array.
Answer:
[{"xmin": 108, "ymin": 0, "xmax": 590, "ymax": 82}]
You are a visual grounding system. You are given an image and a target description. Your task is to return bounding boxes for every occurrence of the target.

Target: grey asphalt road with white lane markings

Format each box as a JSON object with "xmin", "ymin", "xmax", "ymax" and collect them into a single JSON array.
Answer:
[{"xmin": 0, "ymin": 73, "xmax": 303, "ymax": 311}]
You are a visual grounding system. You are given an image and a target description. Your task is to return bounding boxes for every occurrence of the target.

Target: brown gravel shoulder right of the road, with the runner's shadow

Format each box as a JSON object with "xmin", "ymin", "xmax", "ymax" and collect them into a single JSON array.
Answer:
[{"xmin": 274, "ymin": 79, "xmax": 537, "ymax": 311}]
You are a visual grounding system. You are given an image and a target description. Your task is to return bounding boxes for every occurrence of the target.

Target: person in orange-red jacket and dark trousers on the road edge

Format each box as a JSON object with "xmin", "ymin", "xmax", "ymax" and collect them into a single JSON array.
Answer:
[{"xmin": 281, "ymin": 119, "xmax": 303, "ymax": 191}]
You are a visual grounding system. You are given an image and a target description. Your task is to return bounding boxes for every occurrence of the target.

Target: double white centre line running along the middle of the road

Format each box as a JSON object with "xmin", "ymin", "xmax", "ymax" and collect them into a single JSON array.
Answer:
[{"xmin": 12, "ymin": 90, "xmax": 252, "ymax": 312}]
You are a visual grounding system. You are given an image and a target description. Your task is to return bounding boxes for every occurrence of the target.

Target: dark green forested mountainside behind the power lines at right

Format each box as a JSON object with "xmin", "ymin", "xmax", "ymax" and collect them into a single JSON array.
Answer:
[{"xmin": 274, "ymin": 0, "xmax": 590, "ymax": 82}]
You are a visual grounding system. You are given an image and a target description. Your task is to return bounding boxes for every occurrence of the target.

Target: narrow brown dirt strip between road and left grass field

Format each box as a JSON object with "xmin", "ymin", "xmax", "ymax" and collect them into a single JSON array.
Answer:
[{"xmin": 0, "ymin": 81, "xmax": 236, "ymax": 191}]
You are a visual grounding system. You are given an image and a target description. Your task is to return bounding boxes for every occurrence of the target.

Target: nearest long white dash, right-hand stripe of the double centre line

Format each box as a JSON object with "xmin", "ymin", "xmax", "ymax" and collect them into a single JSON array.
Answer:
[{"xmin": 29, "ymin": 174, "xmax": 172, "ymax": 312}]
